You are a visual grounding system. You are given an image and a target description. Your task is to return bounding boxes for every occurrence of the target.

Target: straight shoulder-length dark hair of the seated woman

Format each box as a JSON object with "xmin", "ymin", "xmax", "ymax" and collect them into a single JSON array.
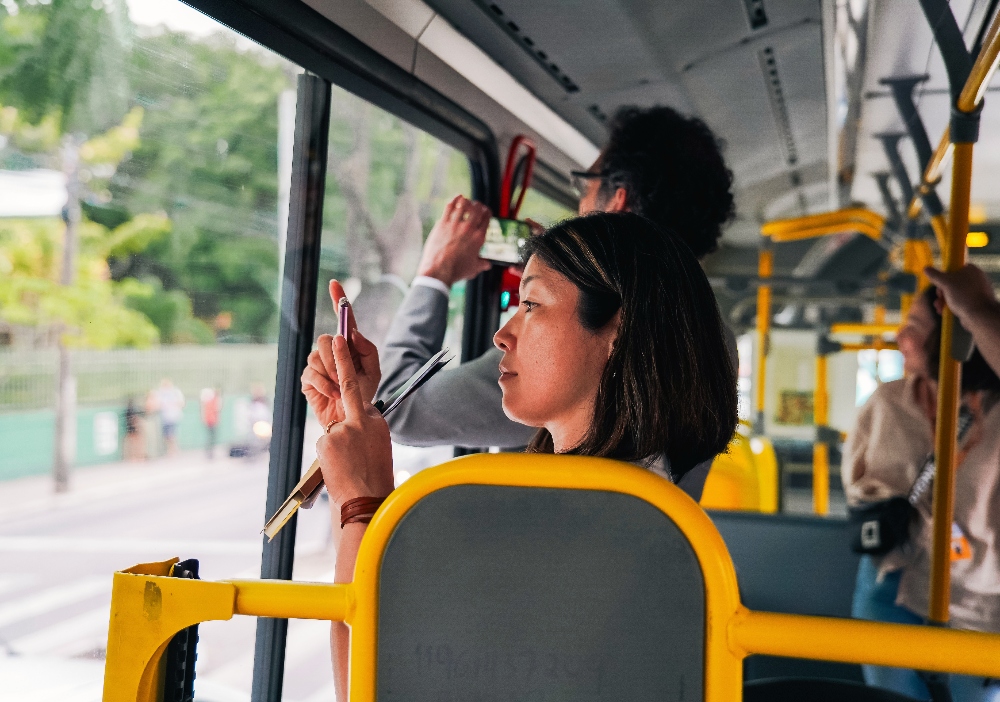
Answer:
[{"xmin": 525, "ymin": 213, "xmax": 737, "ymax": 479}]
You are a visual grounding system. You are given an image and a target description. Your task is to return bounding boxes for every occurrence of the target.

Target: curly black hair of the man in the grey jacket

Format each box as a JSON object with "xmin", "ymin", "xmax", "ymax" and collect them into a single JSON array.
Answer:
[{"xmin": 600, "ymin": 107, "xmax": 735, "ymax": 258}]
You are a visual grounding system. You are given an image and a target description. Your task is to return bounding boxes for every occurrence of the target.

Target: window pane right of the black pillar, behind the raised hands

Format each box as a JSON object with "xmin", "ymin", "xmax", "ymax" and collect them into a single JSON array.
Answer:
[{"xmin": 284, "ymin": 86, "xmax": 472, "ymax": 700}]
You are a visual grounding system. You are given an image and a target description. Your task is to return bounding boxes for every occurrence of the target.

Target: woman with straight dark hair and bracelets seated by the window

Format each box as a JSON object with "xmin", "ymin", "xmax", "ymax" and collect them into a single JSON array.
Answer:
[{"xmin": 303, "ymin": 213, "xmax": 737, "ymax": 699}]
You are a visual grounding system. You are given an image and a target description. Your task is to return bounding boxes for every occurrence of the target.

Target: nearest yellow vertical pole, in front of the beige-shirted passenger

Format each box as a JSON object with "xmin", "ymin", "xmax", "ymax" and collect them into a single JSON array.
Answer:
[{"xmin": 929, "ymin": 143, "xmax": 973, "ymax": 624}]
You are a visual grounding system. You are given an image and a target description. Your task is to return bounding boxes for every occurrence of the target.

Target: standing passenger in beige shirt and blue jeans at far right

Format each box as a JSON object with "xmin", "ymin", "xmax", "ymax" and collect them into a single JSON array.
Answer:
[{"xmin": 842, "ymin": 266, "xmax": 1000, "ymax": 700}]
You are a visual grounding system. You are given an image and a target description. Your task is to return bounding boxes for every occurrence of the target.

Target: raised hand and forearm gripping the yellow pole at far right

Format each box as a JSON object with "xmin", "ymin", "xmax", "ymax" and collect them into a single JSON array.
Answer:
[{"xmin": 924, "ymin": 263, "xmax": 1000, "ymax": 375}]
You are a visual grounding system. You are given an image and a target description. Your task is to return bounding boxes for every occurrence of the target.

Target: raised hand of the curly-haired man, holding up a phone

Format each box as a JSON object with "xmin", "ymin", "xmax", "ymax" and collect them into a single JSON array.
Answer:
[{"xmin": 417, "ymin": 195, "xmax": 491, "ymax": 286}]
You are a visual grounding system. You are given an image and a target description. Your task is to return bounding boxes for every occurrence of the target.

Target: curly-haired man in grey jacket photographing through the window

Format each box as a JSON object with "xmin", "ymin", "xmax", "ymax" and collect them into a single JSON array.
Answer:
[{"xmin": 344, "ymin": 107, "xmax": 736, "ymax": 499}]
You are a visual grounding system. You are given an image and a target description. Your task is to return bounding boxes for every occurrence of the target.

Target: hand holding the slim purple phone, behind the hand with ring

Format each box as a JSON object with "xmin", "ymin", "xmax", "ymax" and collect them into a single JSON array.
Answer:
[{"xmin": 302, "ymin": 280, "xmax": 382, "ymax": 427}]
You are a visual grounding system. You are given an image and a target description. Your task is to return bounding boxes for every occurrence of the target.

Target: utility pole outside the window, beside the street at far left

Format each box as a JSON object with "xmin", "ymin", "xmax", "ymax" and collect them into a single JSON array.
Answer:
[{"xmin": 52, "ymin": 134, "xmax": 82, "ymax": 492}]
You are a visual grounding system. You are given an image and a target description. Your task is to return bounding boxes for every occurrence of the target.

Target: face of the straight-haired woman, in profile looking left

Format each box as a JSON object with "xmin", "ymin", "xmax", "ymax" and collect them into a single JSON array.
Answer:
[{"xmin": 493, "ymin": 256, "xmax": 618, "ymax": 451}]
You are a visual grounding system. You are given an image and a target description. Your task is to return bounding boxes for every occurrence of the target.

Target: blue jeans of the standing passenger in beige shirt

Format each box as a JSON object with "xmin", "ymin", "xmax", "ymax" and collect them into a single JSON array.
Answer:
[{"xmin": 851, "ymin": 556, "xmax": 1000, "ymax": 702}]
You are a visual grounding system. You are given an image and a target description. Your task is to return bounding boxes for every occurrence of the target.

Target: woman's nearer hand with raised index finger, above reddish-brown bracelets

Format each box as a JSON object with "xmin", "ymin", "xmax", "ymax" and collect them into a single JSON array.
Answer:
[{"xmin": 316, "ymin": 336, "xmax": 393, "ymax": 515}]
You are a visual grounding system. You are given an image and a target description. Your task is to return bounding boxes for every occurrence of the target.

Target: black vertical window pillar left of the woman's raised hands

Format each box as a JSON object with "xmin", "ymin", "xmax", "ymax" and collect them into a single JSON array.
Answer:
[{"xmin": 250, "ymin": 74, "xmax": 330, "ymax": 702}]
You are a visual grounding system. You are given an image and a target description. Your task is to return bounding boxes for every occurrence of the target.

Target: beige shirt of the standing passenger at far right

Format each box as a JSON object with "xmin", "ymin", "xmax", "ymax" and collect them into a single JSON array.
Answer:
[{"xmin": 841, "ymin": 379, "xmax": 1000, "ymax": 632}]
